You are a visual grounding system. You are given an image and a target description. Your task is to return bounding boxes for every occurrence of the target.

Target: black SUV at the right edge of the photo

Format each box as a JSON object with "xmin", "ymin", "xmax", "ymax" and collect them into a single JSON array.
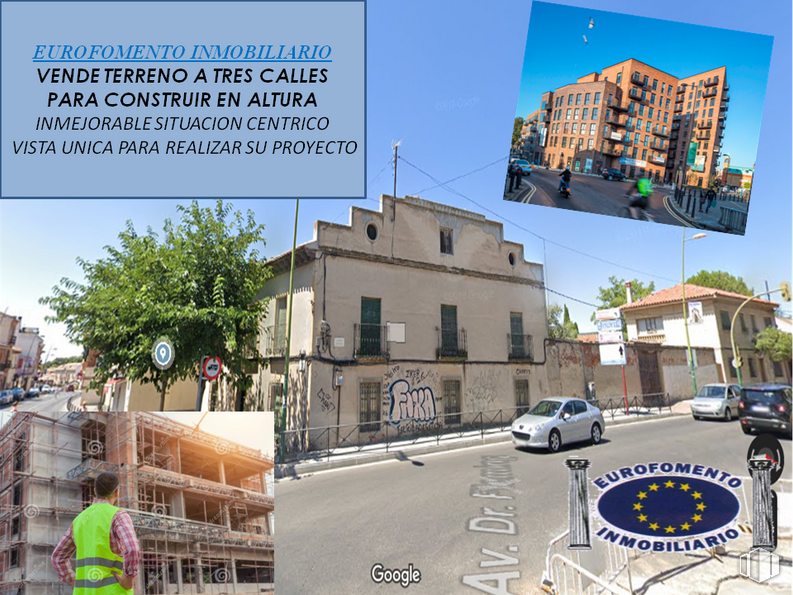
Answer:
[{"xmin": 738, "ymin": 384, "xmax": 791, "ymax": 435}]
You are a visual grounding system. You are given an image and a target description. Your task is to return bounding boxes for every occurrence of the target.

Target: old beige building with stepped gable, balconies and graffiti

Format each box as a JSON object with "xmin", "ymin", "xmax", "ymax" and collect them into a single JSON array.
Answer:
[{"xmin": 257, "ymin": 196, "xmax": 547, "ymax": 448}]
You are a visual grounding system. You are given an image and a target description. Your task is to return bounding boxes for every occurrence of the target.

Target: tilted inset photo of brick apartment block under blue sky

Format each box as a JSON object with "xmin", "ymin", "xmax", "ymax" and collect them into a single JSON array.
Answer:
[{"xmin": 504, "ymin": 2, "xmax": 772, "ymax": 235}]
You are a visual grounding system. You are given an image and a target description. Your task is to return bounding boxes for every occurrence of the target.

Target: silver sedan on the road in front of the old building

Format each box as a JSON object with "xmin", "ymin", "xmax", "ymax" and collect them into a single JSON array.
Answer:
[{"xmin": 512, "ymin": 397, "xmax": 606, "ymax": 452}]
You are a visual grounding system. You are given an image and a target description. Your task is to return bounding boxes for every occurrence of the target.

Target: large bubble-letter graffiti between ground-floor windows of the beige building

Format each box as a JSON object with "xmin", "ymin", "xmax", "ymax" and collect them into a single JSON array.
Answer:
[{"xmin": 383, "ymin": 365, "xmax": 440, "ymax": 434}]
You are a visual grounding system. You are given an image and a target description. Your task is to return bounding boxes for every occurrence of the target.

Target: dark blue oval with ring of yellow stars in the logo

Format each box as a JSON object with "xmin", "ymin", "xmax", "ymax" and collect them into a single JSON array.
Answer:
[{"xmin": 597, "ymin": 475, "xmax": 741, "ymax": 539}]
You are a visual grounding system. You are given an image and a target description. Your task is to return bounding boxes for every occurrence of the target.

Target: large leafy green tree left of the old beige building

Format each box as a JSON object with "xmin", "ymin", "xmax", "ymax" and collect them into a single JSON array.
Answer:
[{"xmin": 40, "ymin": 200, "xmax": 270, "ymax": 410}]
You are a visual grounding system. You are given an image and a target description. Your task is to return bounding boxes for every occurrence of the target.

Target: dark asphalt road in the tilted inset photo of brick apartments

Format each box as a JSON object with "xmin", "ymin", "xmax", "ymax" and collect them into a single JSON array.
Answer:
[{"xmin": 506, "ymin": 168, "xmax": 688, "ymax": 227}]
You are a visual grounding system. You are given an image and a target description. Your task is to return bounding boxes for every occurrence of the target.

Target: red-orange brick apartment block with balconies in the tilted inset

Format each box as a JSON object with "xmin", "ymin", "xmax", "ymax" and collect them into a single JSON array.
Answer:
[{"xmin": 540, "ymin": 59, "xmax": 730, "ymax": 185}]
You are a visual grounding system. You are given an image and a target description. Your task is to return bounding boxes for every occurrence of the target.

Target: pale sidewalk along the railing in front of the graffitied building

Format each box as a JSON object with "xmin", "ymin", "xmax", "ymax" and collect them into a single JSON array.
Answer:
[{"xmin": 275, "ymin": 400, "xmax": 691, "ymax": 479}]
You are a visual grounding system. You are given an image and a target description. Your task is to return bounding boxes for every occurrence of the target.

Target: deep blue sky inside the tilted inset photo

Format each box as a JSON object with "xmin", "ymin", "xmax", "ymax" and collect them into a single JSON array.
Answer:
[{"xmin": 516, "ymin": 2, "xmax": 773, "ymax": 167}]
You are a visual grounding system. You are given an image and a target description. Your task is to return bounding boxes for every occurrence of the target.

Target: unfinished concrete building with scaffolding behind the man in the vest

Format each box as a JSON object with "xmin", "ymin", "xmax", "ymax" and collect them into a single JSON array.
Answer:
[{"xmin": 0, "ymin": 412, "xmax": 274, "ymax": 595}]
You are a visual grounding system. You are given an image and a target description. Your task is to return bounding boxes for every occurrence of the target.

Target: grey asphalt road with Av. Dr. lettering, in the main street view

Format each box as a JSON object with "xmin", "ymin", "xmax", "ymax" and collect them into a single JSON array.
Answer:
[{"xmin": 275, "ymin": 416, "xmax": 793, "ymax": 595}]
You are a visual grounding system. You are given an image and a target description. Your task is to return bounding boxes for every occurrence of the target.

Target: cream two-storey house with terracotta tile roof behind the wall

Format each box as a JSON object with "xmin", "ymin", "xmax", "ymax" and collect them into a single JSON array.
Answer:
[{"xmin": 622, "ymin": 283, "xmax": 790, "ymax": 384}]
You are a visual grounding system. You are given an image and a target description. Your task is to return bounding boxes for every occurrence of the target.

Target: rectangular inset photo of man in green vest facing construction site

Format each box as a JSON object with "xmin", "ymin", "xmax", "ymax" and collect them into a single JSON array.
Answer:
[{"xmin": 0, "ymin": 411, "xmax": 275, "ymax": 595}]
